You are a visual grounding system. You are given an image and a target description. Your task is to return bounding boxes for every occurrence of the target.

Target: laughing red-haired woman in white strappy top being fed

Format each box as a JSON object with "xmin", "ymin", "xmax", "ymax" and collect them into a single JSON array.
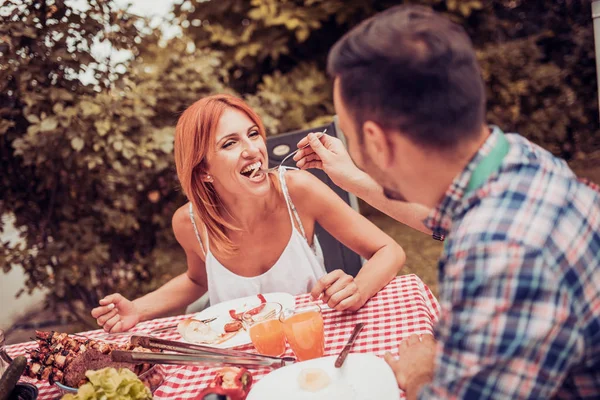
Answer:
[{"xmin": 92, "ymin": 94, "xmax": 405, "ymax": 332}]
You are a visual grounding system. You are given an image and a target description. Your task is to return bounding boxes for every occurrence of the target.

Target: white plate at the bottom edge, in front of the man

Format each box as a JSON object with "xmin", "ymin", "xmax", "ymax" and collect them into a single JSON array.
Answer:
[{"xmin": 246, "ymin": 353, "xmax": 400, "ymax": 400}]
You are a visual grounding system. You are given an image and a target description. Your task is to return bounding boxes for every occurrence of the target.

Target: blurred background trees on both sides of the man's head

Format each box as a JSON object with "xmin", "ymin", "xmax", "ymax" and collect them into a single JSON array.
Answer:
[{"xmin": 174, "ymin": 0, "xmax": 600, "ymax": 153}]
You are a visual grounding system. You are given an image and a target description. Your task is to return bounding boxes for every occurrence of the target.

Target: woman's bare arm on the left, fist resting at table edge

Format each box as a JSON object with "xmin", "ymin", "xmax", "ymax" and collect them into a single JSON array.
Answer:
[{"xmin": 92, "ymin": 207, "xmax": 208, "ymax": 333}]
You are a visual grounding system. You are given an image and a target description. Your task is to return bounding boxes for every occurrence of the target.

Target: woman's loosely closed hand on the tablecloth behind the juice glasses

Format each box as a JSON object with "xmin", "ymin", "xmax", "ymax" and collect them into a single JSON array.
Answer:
[{"xmin": 310, "ymin": 269, "xmax": 366, "ymax": 311}]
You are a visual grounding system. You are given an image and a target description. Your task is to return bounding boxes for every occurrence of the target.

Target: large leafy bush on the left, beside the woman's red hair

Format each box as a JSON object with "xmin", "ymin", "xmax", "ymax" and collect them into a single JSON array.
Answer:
[{"xmin": 0, "ymin": 1, "xmax": 227, "ymax": 319}]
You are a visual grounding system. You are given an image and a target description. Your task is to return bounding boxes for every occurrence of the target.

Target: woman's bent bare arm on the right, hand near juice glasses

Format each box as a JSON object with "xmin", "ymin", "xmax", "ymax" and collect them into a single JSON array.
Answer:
[{"xmin": 286, "ymin": 171, "xmax": 406, "ymax": 310}]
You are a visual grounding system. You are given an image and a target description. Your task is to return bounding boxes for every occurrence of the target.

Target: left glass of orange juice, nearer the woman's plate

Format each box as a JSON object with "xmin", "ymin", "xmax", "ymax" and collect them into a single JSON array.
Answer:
[{"xmin": 242, "ymin": 303, "xmax": 285, "ymax": 357}]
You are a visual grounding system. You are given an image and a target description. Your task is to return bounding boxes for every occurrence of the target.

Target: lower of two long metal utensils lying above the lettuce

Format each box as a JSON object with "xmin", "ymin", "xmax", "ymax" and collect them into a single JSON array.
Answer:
[{"xmin": 110, "ymin": 350, "xmax": 296, "ymax": 368}]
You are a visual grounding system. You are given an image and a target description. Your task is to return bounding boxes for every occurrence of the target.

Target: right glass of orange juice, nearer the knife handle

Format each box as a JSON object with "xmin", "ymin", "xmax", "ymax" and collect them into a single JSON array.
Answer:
[{"xmin": 279, "ymin": 304, "xmax": 325, "ymax": 361}]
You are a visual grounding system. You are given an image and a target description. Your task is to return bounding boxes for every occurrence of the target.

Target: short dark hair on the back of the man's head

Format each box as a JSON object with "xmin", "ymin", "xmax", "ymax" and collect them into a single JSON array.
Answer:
[{"xmin": 327, "ymin": 5, "xmax": 485, "ymax": 148}]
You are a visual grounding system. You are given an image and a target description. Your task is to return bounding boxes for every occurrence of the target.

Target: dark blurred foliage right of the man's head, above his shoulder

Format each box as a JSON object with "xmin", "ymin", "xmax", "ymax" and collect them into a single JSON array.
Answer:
[{"xmin": 469, "ymin": 1, "xmax": 600, "ymax": 164}]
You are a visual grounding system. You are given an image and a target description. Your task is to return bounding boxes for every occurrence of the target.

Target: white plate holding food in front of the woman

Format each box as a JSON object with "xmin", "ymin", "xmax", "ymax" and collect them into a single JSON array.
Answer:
[{"xmin": 183, "ymin": 293, "xmax": 296, "ymax": 349}]
